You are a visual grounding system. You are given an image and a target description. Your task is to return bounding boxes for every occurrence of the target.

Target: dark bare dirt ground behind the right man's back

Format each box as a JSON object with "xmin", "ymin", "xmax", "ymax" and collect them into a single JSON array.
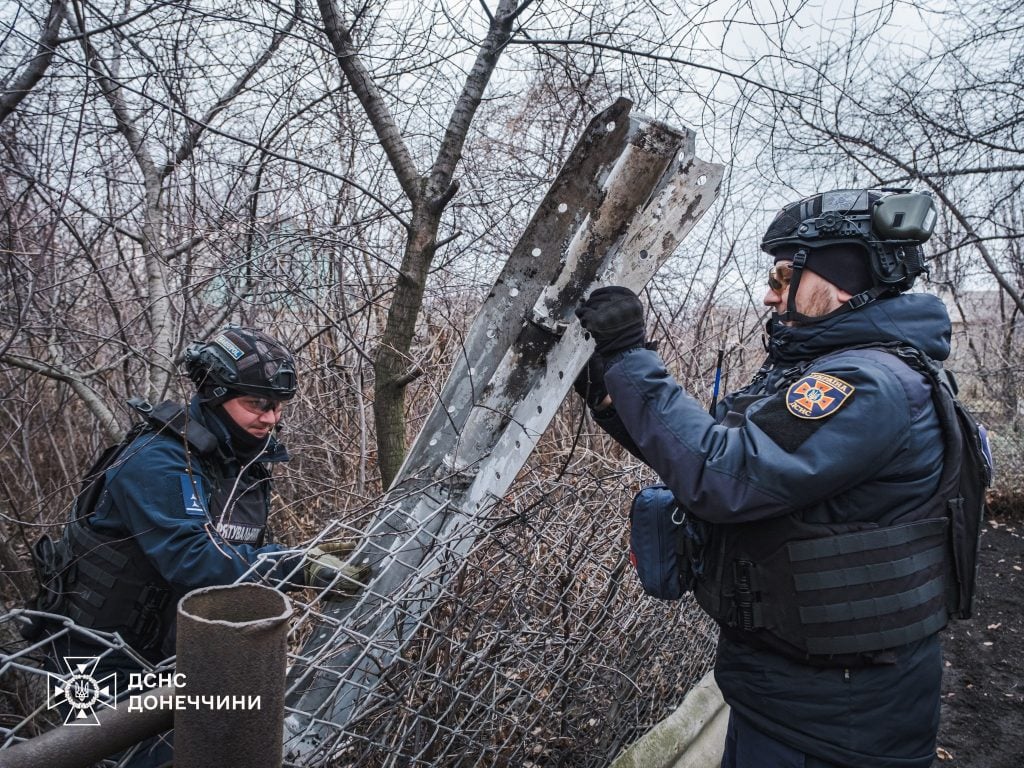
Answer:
[{"xmin": 933, "ymin": 517, "xmax": 1024, "ymax": 768}]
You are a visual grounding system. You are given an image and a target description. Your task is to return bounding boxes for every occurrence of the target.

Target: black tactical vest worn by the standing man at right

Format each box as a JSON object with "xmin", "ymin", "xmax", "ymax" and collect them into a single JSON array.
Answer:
[{"xmin": 694, "ymin": 347, "xmax": 990, "ymax": 666}]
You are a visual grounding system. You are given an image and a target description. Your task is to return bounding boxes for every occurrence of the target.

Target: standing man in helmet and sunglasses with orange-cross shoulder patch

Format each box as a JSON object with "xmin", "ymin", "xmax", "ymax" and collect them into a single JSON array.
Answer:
[{"xmin": 577, "ymin": 189, "xmax": 950, "ymax": 768}]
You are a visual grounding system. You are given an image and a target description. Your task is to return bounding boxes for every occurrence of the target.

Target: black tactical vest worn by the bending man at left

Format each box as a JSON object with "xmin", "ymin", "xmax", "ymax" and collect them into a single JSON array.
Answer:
[{"xmin": 53, "ymin": 402, "xmax": 270, "ymax": 657}]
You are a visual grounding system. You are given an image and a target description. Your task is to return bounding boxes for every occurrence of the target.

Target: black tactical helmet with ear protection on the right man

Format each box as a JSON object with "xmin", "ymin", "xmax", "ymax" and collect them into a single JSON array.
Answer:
[{"xmin": 761, "ymin": 189, "xmax": 936, "ymax": 291}]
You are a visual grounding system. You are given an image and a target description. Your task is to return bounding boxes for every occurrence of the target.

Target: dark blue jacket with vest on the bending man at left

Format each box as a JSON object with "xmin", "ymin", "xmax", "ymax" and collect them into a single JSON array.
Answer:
[{"xmin": 55, "ymin": 399, "xmax": 303, "ymax": 660}]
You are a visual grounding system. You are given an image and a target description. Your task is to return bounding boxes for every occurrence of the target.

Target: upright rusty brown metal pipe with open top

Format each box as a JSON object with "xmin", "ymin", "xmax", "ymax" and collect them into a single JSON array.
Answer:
[{"xmin": 174, "ymin": 584, "xmax": 292, "ymax": 768}]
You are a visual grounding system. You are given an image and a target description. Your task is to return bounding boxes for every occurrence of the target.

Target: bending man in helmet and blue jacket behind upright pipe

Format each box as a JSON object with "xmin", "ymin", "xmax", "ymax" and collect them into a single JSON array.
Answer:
[{"xmin": 40, "ymin": 327, "xmax": 367, "ymax": 766}]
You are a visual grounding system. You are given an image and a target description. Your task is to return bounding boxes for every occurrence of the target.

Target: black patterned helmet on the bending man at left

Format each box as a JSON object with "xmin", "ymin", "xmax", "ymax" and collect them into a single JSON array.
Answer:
[{"xmin": 185, "ymin": 326, "xmax": 297, "ymax": 401}]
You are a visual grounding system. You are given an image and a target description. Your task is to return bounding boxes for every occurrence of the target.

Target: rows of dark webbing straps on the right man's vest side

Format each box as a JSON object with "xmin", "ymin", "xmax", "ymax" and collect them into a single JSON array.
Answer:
[{"xmin": 782, "ymin": 518, "xmax": 949, "ymax": 655}]
